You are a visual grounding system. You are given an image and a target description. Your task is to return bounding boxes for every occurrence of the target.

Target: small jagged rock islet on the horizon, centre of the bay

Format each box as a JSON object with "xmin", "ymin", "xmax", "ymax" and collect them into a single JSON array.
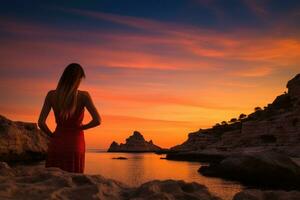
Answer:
[{"xmin": 108, "ymin": 131, "xmax": 162, "ymax": 152}]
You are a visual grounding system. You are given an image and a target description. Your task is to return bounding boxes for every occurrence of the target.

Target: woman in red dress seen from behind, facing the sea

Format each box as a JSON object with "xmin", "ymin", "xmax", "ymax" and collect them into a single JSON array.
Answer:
[{"xmin": 38, "ymin": 63, "xmax": 101, "ymax": 173}]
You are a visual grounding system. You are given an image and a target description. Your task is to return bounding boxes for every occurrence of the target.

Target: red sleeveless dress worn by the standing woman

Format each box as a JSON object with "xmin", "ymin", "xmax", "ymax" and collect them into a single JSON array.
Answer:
[{"xmin": 45, "ymin": 109, "xmax": 85, "ymax": 173}]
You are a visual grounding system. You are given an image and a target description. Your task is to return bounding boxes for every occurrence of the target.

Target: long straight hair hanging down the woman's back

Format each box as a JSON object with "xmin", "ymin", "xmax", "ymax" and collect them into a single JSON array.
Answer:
[{"xmin": 56, "ymin": 63, "xmax": 85, "ymax": 119}]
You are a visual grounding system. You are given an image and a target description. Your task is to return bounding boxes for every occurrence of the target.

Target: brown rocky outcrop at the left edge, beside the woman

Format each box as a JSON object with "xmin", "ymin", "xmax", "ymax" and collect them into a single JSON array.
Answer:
[{"xmin": 0, "ymin": 115, "xmax": 50, "ymax": 161}]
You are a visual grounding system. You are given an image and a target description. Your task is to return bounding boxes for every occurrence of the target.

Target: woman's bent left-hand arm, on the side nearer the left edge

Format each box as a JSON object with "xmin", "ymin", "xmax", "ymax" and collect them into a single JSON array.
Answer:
[{"xmin": 38, "ymin": 91, "xmax": 53, "ymax": 137}]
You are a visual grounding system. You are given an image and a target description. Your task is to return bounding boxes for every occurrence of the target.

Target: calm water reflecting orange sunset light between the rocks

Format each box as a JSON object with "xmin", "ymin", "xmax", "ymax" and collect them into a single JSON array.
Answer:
[{"xmin": 85, "ymin": 151, "xmax": 243, "ymax": 200}]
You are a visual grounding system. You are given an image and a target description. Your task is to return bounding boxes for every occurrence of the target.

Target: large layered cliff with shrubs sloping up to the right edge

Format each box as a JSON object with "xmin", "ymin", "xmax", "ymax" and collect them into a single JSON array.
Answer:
[{"xmin": 170, "ymin": 74, "xmax": 300, "ymax": 158}]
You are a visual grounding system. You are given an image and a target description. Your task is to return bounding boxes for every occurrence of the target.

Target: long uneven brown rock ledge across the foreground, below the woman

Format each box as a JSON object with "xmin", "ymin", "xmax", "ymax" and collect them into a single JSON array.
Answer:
[{"xmin": 0, "ymin": 163, "xmax": 219, "ymax": 200}]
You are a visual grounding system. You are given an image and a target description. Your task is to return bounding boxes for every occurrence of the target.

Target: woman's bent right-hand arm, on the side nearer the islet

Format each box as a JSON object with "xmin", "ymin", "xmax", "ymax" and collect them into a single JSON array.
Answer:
[{"xmin": 80, "ymin": 92, "xmax": 101, "ymax": 130}]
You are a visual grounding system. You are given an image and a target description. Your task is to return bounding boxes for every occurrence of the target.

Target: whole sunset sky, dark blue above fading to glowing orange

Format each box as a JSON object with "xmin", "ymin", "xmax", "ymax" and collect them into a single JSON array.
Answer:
[{"xmin": 0, "ymin": 0, "xmax": 300, "ymax": 149}]
